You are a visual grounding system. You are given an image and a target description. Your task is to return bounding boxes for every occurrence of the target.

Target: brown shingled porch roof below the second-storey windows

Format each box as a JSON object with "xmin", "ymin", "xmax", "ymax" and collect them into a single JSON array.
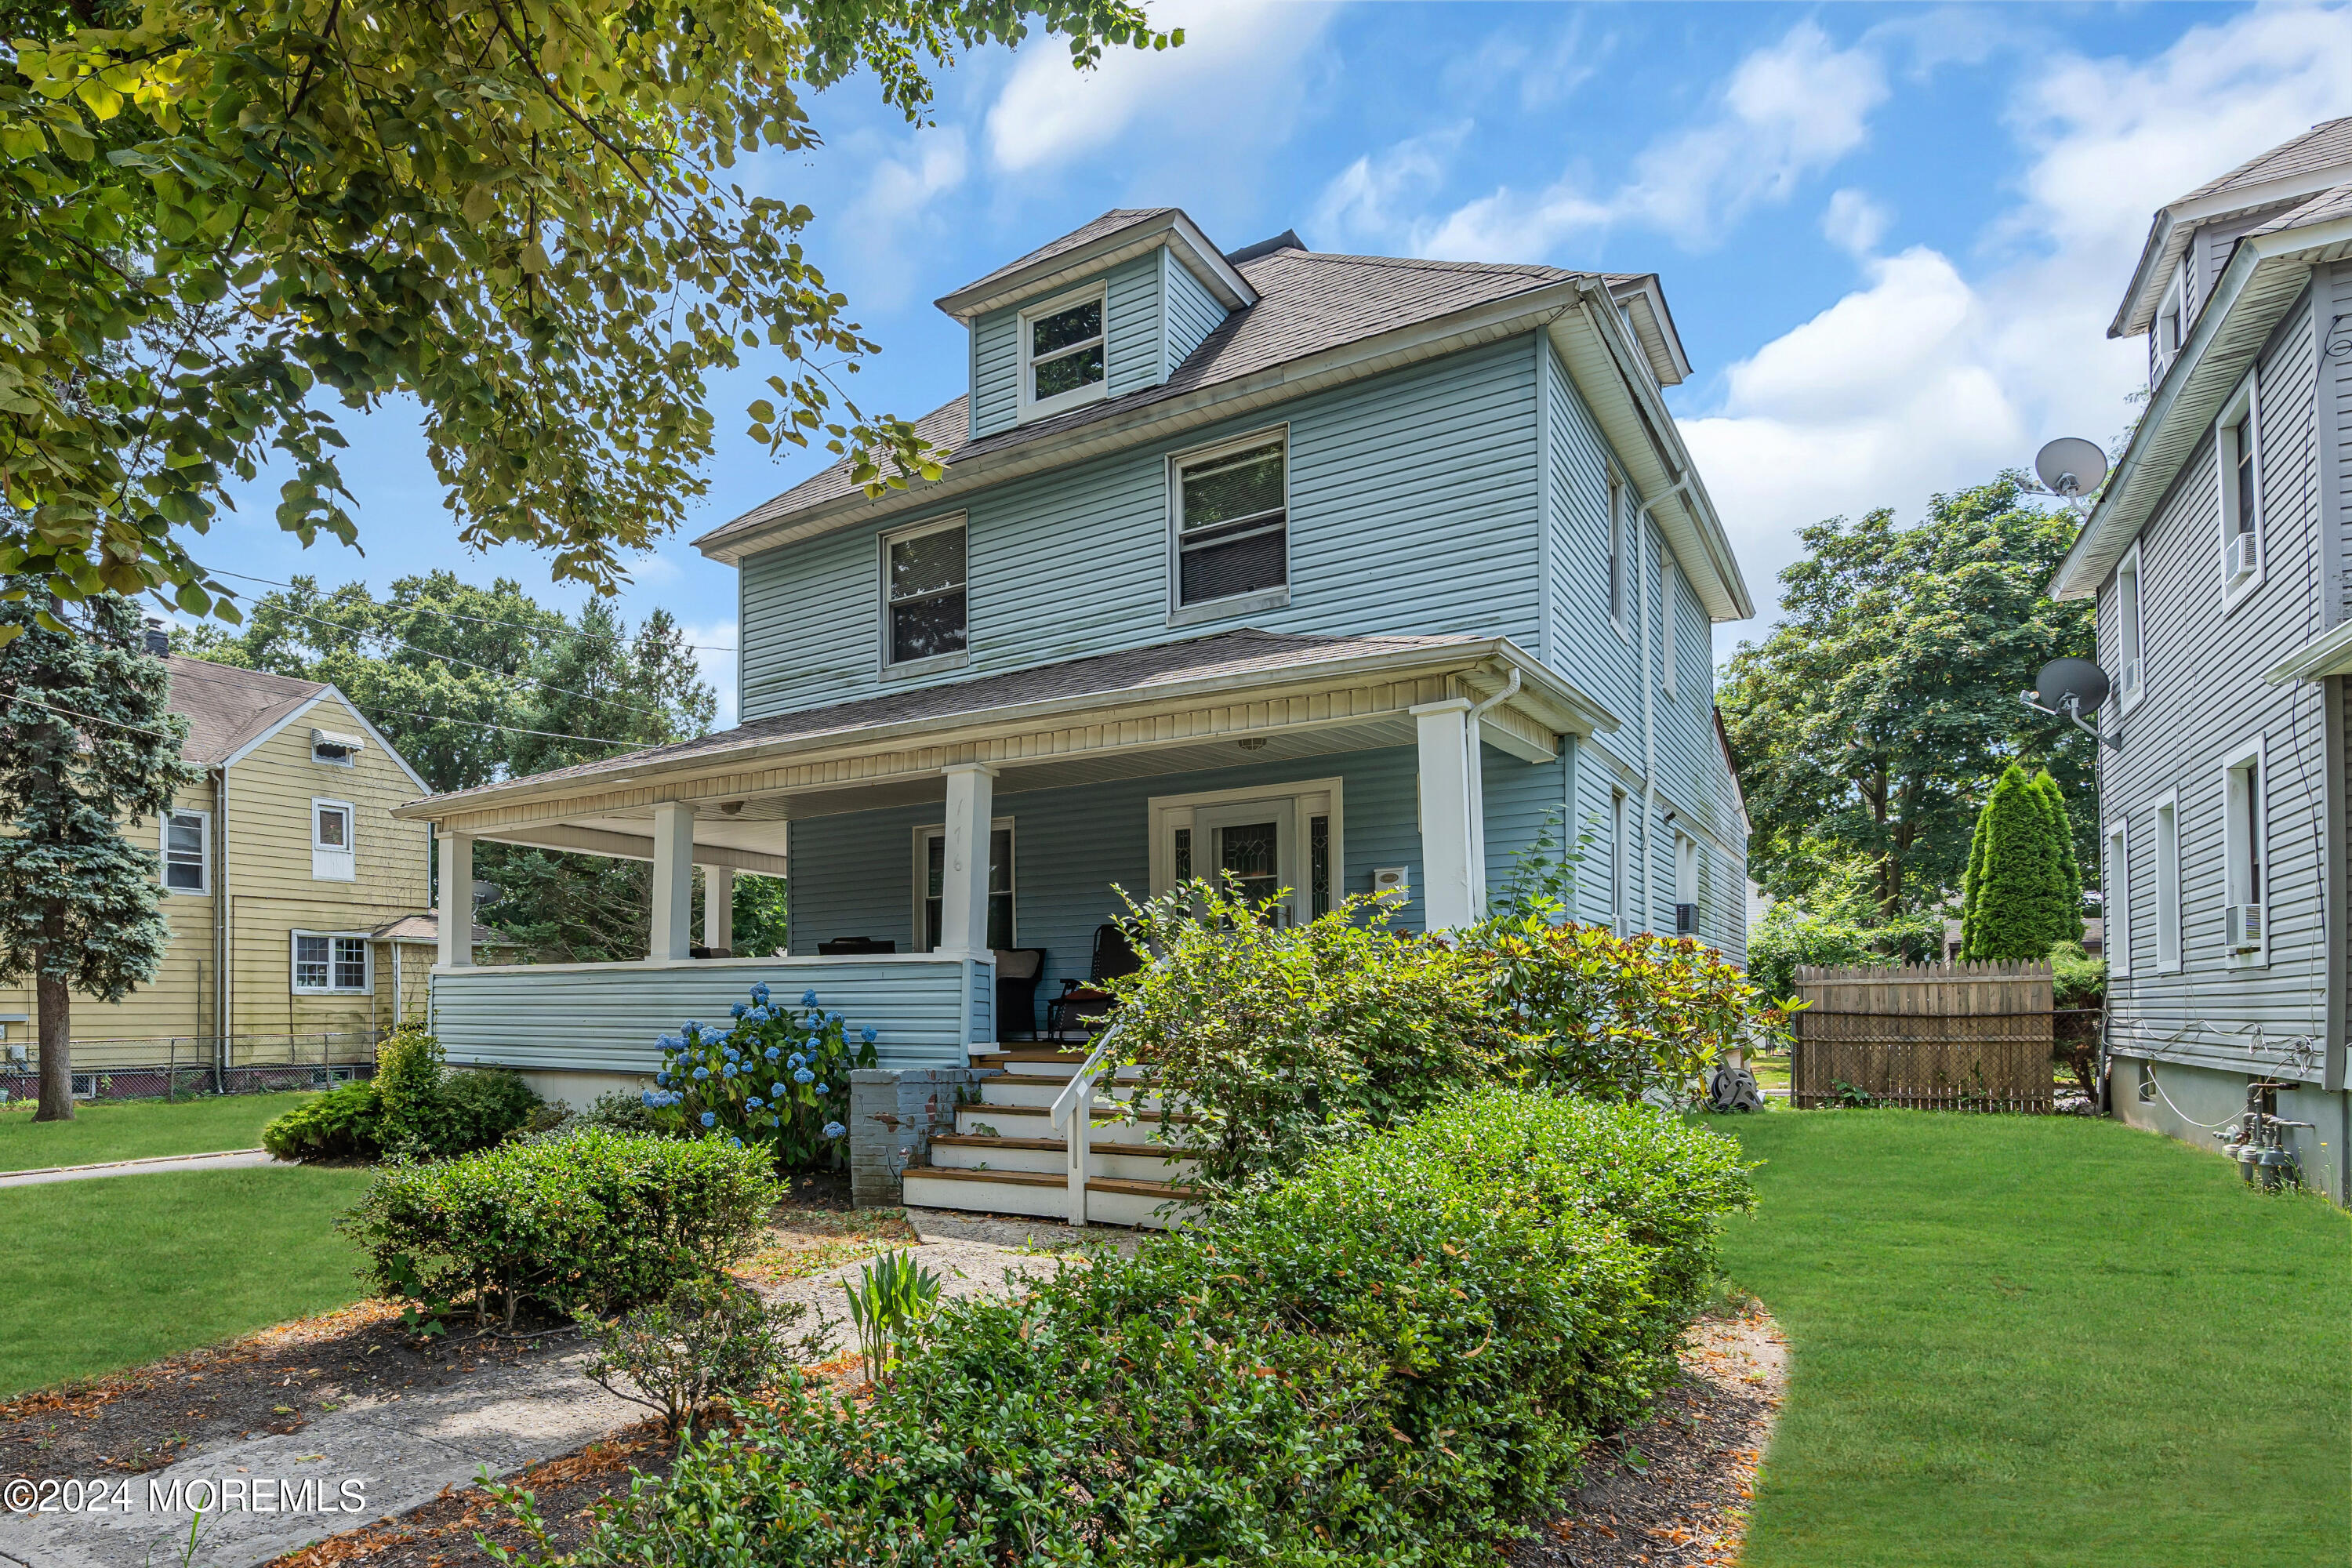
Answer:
[{"xmin": 416, "ymin": 628, "xmax": 1486, "ymax": 804}]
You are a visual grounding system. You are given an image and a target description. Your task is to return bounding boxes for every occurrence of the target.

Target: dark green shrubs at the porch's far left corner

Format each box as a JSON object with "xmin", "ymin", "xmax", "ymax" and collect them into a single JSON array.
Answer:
[{"xmin": 261, "ymin": 1029, "xmax": 539, "ymax": 1159}]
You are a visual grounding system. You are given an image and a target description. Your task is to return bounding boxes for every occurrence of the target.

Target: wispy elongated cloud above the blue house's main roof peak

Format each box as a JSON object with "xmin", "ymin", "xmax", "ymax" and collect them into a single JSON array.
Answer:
[{"xmin": 1411, "ymin": 21, "xmax": 1886, "ymax": 261}]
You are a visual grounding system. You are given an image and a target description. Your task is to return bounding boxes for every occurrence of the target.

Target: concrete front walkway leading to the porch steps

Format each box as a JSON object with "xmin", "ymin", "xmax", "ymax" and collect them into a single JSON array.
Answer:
[{"xmin": 0, "ymin": 1213, "xmax": 1136, "ymax": 1568}]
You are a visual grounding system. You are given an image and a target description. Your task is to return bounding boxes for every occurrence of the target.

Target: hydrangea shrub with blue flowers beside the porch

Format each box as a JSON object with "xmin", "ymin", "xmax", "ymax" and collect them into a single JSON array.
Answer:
[{"xmin": 644, "ymin": 980, "xmax": 875, "ymax": 1168}]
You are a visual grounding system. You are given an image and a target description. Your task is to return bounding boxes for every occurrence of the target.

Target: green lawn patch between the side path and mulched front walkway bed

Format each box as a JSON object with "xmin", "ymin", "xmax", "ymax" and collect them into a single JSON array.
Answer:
[{"xmin": 0, "ymin": 1168, "xmax": 369, "ymax": 1399}]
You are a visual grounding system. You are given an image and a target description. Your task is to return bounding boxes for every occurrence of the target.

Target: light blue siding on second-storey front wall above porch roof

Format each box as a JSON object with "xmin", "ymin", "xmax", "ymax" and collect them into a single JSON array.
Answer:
[{"xmin": 743, "ymin": 341, "xmax": 1543, "ymax": 720}]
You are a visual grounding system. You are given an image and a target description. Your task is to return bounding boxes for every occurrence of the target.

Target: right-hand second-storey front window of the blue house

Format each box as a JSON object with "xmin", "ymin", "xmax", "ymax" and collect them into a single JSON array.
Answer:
[{"xmin": 1169, "ymin": 430, "xmax": 1291, "ymax": 621}]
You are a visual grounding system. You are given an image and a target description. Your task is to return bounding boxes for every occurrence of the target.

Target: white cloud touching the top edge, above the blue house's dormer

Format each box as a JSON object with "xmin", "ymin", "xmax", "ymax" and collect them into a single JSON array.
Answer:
[{"xmin": 988, "ymin": 0, "xmax": 1331, "ymax": 174}]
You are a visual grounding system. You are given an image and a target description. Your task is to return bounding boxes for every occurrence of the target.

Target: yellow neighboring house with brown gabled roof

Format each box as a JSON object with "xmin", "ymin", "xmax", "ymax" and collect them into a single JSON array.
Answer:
[{"xmin": 0, "ymin": 656, "xmax": 435, "ymax": 1093}]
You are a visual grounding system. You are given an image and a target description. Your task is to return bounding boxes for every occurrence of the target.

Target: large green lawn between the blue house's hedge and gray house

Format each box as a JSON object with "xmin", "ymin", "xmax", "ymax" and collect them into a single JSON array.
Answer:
[{"xmin": 1715, "ymin": 1109, "xmax": 2352, "ymax": 1568}]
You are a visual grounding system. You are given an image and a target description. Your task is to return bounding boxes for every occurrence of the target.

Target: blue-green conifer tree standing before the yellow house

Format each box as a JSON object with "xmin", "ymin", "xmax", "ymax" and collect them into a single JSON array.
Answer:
[{"xmin": 0, "ymin": 576, "xmax": 198, "ymax": 1121}]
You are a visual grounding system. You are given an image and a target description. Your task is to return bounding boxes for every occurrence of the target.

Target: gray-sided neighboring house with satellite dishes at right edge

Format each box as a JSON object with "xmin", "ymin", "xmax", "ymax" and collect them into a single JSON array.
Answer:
[{"xmin": 2051, "ymin": 120, "xmax": 2352, "ymax": 1201}]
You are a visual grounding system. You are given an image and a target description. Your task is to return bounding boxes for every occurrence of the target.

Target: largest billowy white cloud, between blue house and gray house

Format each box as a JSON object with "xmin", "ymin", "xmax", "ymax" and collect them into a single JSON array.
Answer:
[{"xmin": 1682, "ymin": 0, "xmax": 2352, "ymax": 637}]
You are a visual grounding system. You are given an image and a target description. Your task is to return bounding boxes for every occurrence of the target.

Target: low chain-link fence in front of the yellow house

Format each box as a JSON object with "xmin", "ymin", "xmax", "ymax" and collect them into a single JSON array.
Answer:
[{"xmin": 0, "ymin": 1029, "xmax": 383, "ymax": 1105}]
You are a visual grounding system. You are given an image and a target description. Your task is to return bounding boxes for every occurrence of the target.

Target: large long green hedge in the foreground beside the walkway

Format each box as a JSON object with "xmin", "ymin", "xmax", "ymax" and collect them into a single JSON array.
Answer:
[{"xmin": 515, "ymin": 1088, "xmax": 1750, "ymax": 1568}]
